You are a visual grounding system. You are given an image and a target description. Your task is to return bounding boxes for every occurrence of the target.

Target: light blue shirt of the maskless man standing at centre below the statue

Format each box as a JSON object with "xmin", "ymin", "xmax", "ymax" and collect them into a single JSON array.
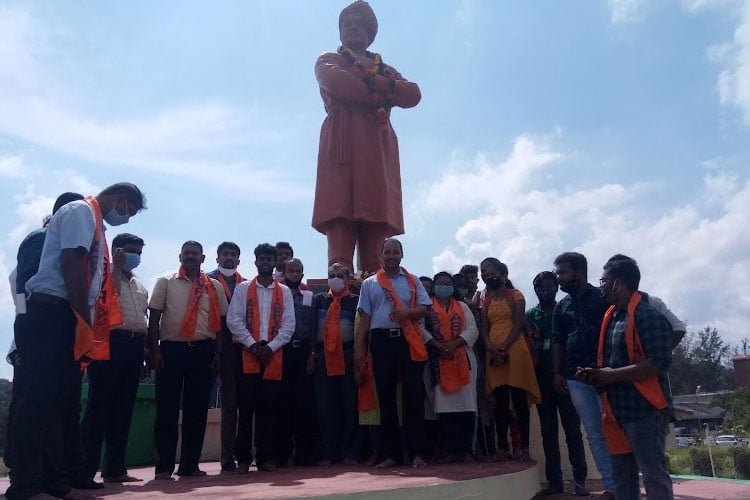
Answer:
[{"xmin": 357, "ymin": 270, "xmax": 432, "ymax": 329}]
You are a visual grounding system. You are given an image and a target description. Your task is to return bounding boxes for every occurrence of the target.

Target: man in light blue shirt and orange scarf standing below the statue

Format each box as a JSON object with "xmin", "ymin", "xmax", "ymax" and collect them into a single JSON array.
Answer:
[{"xmin": 354, "ymin": 238, "xmax": 432, "ymax": 468}]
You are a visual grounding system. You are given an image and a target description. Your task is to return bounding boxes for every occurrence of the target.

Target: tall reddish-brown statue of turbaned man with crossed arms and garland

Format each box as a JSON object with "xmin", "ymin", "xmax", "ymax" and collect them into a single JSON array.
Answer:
[{"xmin": 312, "ymin": 0, "xmax": 422, "ymax": 272}]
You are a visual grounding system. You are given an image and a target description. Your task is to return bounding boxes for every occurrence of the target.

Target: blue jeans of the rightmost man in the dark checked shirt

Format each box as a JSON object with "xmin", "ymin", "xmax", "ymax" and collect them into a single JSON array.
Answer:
[{"xmin": 612, "ymin": 411, "xmax": 673, "ymax": 500}]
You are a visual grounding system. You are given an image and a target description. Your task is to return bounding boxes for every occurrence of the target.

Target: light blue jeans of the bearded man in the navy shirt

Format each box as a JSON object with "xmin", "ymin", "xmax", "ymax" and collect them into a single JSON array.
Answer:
[{"xmin": 568, "ymin": 379, "xmax": 619, "ymax": 492}]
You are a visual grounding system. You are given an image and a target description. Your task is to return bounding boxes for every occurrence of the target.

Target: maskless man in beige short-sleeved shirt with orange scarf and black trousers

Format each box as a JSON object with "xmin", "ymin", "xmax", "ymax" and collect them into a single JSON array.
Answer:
[{"xmin": 148, "ymin": 241, "xmax": 227, "ymax": 479}]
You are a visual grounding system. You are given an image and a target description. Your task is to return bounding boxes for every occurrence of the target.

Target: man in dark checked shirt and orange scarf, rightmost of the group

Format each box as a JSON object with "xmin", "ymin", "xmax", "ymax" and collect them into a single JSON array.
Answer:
[{"xmin": 576, "ymin": 259, "xmax": 673, "ymax": 500}]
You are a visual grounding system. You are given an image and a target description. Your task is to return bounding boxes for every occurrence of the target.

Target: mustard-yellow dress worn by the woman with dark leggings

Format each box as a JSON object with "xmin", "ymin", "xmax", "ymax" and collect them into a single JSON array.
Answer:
[{"xmin": 486, "ymin": 290, "xmax": 541, "ymax": 405}]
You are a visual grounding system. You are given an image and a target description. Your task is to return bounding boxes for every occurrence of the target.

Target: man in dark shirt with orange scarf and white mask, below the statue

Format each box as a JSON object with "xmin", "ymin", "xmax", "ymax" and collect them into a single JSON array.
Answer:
[{"xmin": 313, "ymin": 263, "xmax": 359, "ymax": 465}]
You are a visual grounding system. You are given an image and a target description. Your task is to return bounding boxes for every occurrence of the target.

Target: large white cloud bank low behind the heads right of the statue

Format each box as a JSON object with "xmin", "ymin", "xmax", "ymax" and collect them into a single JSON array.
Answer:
[{"xmin": 421, "ymin": 136, "xmax": 750, "ymax": 341}]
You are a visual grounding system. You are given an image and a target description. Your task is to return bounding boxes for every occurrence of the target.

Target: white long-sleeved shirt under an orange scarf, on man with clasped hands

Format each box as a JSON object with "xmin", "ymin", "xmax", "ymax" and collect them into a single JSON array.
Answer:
[{"xmin": 227, "ymin": 281, "xmax": 295, "ymax": 352}]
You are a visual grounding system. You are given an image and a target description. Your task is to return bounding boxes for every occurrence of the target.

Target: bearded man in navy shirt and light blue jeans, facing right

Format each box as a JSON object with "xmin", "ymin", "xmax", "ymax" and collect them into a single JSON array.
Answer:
[{"xmin": 552, "ymin": 252, "xmax": 615, "ymax": 498}]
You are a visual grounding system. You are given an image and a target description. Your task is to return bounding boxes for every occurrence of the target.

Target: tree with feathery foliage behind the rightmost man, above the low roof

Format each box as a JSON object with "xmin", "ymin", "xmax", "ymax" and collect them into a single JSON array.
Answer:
[{"xmin": 669, "ymin": 326, "xmax": 734, "ymax": 395}]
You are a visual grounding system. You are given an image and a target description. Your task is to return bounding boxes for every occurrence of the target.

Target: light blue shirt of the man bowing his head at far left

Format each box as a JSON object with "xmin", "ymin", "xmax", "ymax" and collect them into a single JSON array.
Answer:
[{"xmin": 26, "ymin": 200, "xmax": 104, "ymax": 306}]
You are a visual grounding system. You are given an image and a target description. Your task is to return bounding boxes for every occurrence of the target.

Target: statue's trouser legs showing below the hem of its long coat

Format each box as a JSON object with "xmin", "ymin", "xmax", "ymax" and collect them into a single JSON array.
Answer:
[{"xmin": 326, "ymin": 219, "xmax": 388, "ymax": 273}]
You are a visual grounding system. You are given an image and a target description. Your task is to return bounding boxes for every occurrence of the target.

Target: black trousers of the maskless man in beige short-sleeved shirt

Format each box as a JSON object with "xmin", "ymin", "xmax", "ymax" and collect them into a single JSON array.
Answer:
[{"xmin": 154, "ymin": 339, "xmax": 216, "ymax": 474}]
